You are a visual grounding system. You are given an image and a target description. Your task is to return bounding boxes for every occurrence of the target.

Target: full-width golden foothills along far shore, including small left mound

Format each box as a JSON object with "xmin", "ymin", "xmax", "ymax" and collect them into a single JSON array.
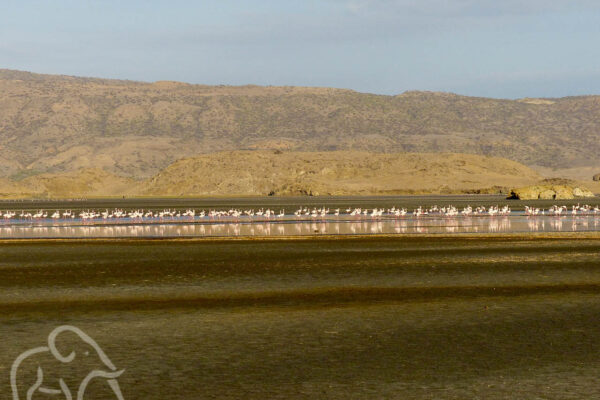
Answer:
[{"xmin": 0, "ymin": 150, "xmax": 600, "ymax": 198}]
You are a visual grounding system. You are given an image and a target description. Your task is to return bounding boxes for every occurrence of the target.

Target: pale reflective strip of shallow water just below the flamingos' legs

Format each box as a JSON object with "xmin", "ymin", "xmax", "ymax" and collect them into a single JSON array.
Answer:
[{"xmin": 0, "ymin": 215, "xmax": 600, "ymax": 239}]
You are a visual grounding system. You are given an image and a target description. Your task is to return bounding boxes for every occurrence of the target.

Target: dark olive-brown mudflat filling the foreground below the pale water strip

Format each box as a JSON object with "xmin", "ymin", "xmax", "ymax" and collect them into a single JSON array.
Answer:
[{"xmin": 0, "ymin": 236, "xmax": 600, "ymax": 400}]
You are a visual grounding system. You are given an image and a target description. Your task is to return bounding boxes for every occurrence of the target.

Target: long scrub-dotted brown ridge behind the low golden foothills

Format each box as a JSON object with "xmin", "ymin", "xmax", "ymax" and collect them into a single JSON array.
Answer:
[{"xmin": 0, "ymin": 70, "xmax": 600, "ymax": 180}]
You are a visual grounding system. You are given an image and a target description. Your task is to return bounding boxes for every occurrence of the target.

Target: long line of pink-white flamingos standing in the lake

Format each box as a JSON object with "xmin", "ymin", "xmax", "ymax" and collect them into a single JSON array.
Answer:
[{"xmin": 0, "ymin": 204, "xmax": 600, "ymax": 223}]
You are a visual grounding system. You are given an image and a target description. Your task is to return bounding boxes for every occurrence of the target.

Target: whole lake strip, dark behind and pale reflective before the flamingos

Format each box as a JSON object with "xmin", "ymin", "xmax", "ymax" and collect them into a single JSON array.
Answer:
[{"xmin": 0, "ymin": 195, "xmax": 600, "ymax": 239}]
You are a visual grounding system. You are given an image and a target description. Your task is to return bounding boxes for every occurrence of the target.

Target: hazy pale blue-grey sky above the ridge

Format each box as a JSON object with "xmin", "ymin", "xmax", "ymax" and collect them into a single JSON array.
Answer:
[{"xmin": 0, "ymin": 0, "xmax": 600, "ymax": 98}]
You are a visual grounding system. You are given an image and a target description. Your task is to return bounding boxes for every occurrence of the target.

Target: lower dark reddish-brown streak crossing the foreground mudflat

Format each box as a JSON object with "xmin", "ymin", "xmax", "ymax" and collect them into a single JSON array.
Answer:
[{"xmin": 0, "ymin": 283, "xmax": 600, "ymax": 318}]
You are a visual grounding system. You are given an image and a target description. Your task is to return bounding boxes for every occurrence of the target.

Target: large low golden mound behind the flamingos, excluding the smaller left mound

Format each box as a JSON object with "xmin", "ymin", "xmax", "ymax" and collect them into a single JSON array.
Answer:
[{"xmin": 138, "ymin": 151, "xmax": 540, "ymax": 196}]
